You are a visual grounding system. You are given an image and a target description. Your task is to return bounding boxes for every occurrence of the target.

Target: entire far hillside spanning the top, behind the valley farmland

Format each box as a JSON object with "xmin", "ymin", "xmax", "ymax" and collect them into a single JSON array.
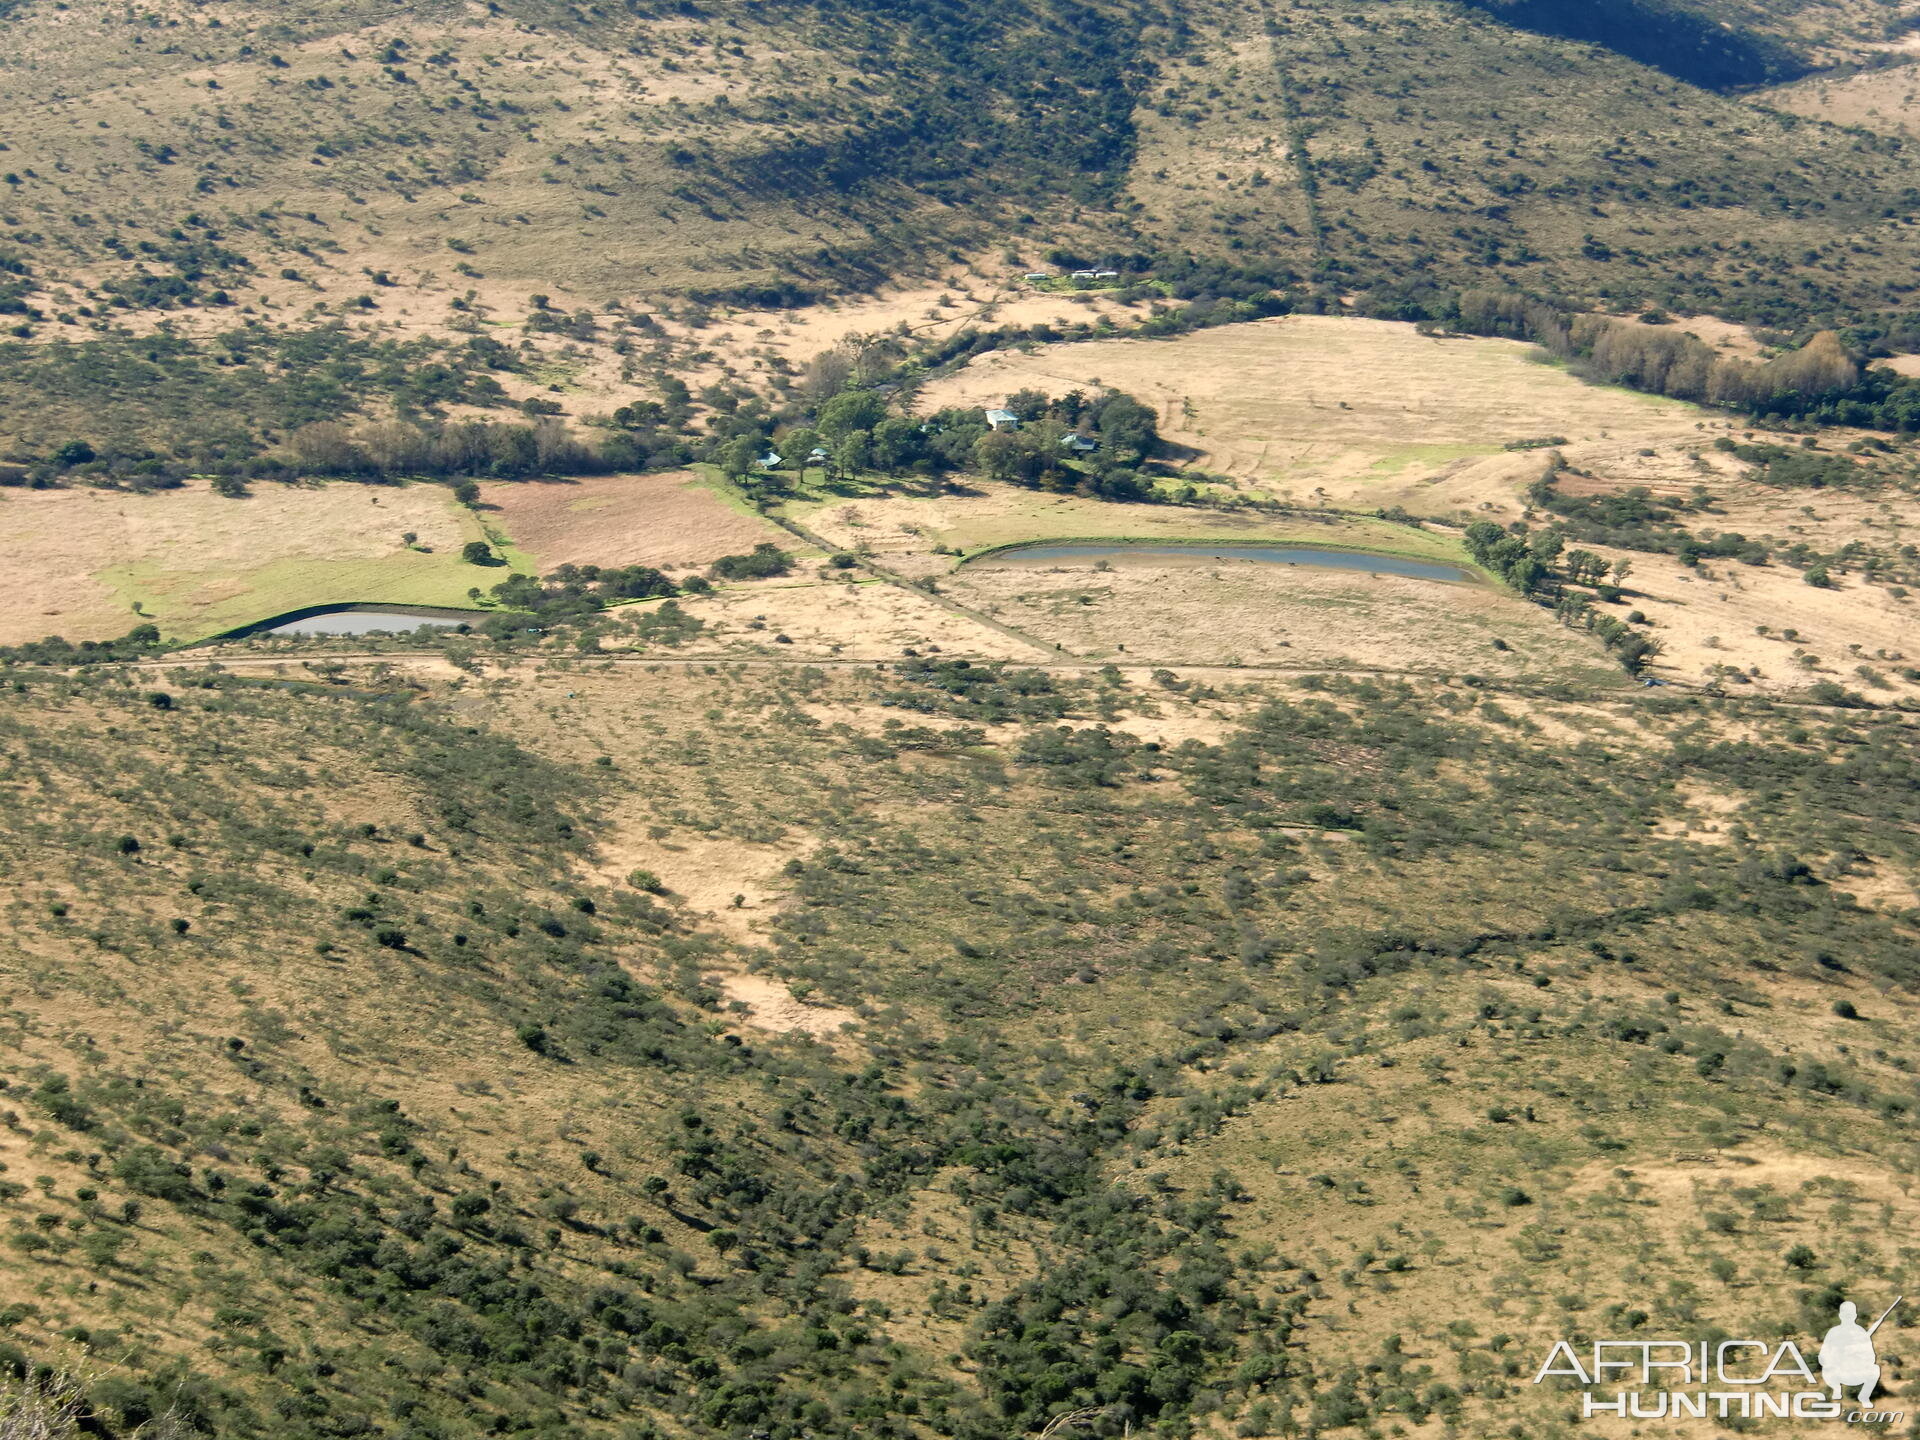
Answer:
[{"xmin": 0, "ymin": 0, "xmax": 1920, "ymax": 468}]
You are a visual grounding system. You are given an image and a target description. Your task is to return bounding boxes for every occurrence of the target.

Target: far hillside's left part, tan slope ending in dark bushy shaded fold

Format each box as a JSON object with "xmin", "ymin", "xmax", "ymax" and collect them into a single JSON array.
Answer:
[{"xmin": 0, "ymin": 0, "xmax": 1154, "ymax": 309}]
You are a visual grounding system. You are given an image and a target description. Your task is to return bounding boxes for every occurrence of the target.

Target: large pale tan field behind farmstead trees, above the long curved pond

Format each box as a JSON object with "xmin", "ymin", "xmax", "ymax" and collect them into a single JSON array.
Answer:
[{"xmin": 922, "ymin": 315, "xmax": 1720, "ymax": 515}]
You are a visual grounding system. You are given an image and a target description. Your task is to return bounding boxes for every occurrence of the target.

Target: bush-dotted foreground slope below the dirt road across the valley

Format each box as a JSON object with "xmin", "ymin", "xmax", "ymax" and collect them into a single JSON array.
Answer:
[{"xmin": 0, "ymin": 659, "xmax": 1920, "ymax": 1440}]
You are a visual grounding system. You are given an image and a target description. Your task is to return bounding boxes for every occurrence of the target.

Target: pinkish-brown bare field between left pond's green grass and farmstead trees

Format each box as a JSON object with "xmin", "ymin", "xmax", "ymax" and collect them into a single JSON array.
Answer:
[{"xmin": 480, "ymin": 470, "xmax": 791, "ymax": 570}]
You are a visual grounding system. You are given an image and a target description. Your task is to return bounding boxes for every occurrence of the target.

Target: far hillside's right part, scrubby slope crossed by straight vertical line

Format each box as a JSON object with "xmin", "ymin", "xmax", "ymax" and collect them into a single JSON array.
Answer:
[{"xmin": 1133, "ymin": 0, "xmax": 1920, "ymax": 326}]
